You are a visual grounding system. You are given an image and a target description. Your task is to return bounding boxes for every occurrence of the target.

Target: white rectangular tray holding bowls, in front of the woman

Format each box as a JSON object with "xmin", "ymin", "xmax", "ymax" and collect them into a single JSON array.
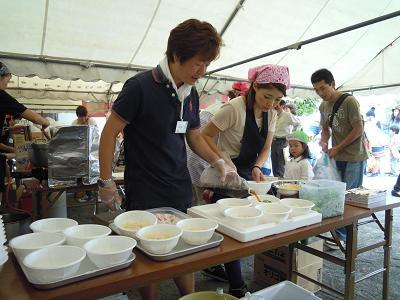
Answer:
[{"xmin": 188, "ymin": 203, "xmax": 322, "ymax": 242}]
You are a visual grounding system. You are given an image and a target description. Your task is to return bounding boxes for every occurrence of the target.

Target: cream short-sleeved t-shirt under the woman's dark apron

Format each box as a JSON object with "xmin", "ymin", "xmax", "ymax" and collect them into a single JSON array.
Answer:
[{"xmin": 211, "ymin": 96, "xmax": 278, "ymax": 158}]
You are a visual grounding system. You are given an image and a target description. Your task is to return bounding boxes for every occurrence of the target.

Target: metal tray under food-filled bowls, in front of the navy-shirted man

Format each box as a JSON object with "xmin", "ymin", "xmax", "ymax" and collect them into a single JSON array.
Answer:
[{"xmin": 109, "ymin": 207, "xmax": 224, "ymax": 261}]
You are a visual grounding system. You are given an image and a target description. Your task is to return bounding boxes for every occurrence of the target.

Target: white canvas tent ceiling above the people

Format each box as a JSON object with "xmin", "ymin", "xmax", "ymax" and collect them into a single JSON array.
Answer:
[{"xmin": 0, "ymin": 0, "xmax": 400, "ymax": 109}]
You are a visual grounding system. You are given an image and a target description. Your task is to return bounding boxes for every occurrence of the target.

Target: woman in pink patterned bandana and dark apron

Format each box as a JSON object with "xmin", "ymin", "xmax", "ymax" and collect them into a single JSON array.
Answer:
[{"xmin": 202, "ymin": 65, "xmax": 290, "ymax": 298}]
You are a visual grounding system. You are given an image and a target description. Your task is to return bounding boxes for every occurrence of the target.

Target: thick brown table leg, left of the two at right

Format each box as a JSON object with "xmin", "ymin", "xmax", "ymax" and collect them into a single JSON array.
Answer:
[{"xmin": 344, "ymin": 221, "xmax": 358, "ymax": 300}]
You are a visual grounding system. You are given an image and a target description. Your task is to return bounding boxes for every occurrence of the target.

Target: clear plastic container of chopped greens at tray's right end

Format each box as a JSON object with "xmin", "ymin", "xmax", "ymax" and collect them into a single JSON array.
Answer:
[{"xmin": 299, "ymin": 179, "xmax": 346, "ymax": 218}]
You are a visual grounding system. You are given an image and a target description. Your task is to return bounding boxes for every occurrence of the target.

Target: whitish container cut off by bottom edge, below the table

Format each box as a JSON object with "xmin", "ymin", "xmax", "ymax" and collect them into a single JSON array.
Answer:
[{"xmin": 241, "ymin": 280, "xmax": 321, "ymax": 300}]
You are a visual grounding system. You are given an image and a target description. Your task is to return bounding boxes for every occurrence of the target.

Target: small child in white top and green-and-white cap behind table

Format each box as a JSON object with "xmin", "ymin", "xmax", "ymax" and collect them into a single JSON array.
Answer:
[{"xmin": 283, "ymin": 131, "xmax": 314, "ymax": 180}]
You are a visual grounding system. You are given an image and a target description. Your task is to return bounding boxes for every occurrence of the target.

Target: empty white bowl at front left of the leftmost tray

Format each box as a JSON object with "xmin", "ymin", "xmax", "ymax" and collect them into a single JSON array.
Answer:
[{"xmin": 23, "ymin": 245, "xmax": 86, "ymax": 284}]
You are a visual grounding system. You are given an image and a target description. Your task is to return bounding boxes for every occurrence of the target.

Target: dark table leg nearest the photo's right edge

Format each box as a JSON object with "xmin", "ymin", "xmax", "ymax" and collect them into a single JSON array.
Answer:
[{"xmin": 382, "ymin": 209, "xmax": 393, "ymax": 300}]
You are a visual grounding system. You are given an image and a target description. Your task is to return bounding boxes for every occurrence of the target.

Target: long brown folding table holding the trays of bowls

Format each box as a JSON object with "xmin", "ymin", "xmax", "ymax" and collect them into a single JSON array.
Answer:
[{"xmin": 0, "ymin": 198, "xmax": 400, "ymax": 300}]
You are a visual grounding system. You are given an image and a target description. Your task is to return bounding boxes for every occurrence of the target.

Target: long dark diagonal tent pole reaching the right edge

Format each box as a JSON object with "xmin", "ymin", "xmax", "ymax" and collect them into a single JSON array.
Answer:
[{"xmin": 206, "ymin": 10, "xmax": 400, "ymax": 75}]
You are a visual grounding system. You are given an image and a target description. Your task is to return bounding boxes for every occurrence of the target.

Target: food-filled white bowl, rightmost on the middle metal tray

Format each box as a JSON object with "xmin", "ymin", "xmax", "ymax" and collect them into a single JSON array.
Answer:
[{"xmin": 176, "ymin": 218, "xmax": 218, "ymax": 245}]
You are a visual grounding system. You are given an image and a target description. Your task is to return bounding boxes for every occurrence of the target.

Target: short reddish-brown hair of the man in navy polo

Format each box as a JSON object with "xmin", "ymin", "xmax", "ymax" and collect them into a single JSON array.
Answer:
[{"xmin": 165, "ymin": 19, "xmax": 222, "ymax": 63}]
